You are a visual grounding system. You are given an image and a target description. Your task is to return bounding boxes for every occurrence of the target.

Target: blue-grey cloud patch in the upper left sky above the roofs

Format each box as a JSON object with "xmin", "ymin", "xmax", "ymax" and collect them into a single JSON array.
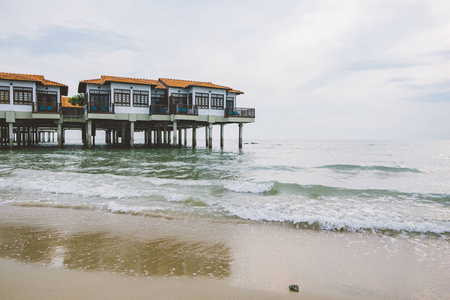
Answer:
[{"xmin": 0, "ymin": 27, "xmax": 135, "ymax": 56}]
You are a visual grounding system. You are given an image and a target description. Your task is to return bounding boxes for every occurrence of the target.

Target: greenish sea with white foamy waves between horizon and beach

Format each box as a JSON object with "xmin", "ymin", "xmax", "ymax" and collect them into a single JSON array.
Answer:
[{"xmin": 0, "ymin": 140, "xmax": 450, "ymax": 239}]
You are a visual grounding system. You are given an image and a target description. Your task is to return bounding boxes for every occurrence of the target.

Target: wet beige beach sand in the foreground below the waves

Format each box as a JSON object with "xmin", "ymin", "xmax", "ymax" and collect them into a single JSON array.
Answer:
[{"xmin": 0, "ymin": 205, "xmax": 450, "ymax": 299}]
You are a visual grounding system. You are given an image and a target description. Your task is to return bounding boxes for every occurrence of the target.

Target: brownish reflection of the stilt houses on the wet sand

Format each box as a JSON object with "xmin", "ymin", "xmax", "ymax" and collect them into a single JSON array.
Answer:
[{"xmin": 0, "ymin": 226, "xmax": 231, "ymax": 278}]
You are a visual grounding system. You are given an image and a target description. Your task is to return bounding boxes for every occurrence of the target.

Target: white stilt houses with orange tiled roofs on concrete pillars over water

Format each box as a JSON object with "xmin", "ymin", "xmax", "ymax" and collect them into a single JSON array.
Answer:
[{"xmin": 0, "ymin": 73, "xmax": 255, "ymax": 149}]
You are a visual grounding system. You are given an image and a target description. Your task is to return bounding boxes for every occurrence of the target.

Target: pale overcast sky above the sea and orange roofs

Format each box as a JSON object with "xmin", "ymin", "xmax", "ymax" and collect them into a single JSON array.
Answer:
[{"xmin": 0, "ymin": 0, "xmax": 450, "ymax": 140}]
